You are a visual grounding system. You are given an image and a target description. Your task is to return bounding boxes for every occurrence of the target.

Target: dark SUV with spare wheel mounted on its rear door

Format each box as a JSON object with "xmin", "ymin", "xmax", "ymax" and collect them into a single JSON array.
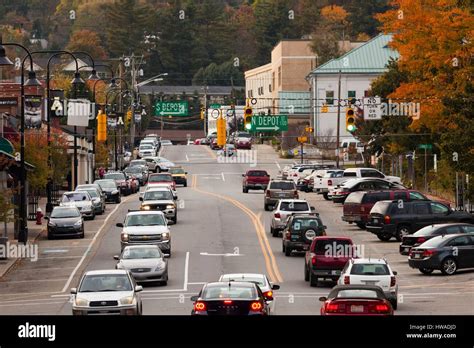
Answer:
[{"xmin": 282, "ymin": 214, "xmax": 326, "ymax": 256}]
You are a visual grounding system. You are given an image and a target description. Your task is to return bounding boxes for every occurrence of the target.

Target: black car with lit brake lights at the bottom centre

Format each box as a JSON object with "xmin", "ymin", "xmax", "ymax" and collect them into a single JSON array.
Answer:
[{"xmin": 191, "ymin": 282, "xmax": 269, "ymax": 316}]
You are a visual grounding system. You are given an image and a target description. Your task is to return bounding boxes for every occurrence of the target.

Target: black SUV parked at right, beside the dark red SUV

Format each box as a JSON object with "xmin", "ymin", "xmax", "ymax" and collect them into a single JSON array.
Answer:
[{"xmin": 366, "ymin": 201, "xmax": 474, "ymax": 242}]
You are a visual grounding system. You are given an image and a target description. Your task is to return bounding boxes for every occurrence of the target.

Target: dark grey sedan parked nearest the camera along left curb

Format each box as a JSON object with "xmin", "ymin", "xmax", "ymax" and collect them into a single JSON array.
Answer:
[{"xmin": 45, "ymin": 207, "xmax": 84, "ymax": 239}]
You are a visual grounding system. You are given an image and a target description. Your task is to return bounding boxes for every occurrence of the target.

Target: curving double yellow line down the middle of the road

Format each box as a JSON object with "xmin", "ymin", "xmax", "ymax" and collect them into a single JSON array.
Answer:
[{"xmin": 191, "ymin": 175, "xmax": 283, "ymax": 283}]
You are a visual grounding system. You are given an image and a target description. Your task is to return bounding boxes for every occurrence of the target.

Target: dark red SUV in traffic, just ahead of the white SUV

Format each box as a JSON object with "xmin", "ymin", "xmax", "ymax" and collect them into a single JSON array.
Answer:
[{"xmin": 304, "ymin": 236, "xmax": 358, "ymax": 286}]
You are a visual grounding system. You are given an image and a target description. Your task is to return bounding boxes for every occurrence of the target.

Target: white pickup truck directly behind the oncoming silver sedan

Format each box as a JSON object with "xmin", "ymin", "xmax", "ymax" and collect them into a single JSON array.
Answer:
[{"xmin": 116, "ymin": 211, "xmax": 171, "ymax": 255}]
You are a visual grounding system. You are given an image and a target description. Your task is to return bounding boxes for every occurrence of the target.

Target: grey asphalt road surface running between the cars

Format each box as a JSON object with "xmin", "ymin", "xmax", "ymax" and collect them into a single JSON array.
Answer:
[{"xmin": 0, "ymin": 145, "xmax": 474, "ymax": 315}]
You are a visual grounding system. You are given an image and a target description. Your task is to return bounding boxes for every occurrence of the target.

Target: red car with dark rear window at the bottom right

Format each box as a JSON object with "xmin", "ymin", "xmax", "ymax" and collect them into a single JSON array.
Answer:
[{"xmin": 319, "ymin": 285, "xmax": 393, "ymax": 316}]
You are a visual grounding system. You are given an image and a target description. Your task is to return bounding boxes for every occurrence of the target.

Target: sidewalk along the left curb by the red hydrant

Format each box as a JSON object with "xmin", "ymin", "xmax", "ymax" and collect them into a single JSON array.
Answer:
[{"xmin": 0, "ymin": 197, "xmax": 46, "ymax": 281}]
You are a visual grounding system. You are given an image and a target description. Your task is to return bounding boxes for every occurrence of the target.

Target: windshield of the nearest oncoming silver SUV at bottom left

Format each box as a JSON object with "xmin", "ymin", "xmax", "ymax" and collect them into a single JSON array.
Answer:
[{"xmin": 79, "ymin": 274, "xmax": 132, "ymax": 292}]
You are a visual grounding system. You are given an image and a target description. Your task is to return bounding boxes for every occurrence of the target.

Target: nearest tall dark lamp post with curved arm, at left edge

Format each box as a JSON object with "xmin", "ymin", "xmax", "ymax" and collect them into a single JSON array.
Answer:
[{"xmin": 0, "ymin": 36, "xmax": 41, "ymax": 244}]
